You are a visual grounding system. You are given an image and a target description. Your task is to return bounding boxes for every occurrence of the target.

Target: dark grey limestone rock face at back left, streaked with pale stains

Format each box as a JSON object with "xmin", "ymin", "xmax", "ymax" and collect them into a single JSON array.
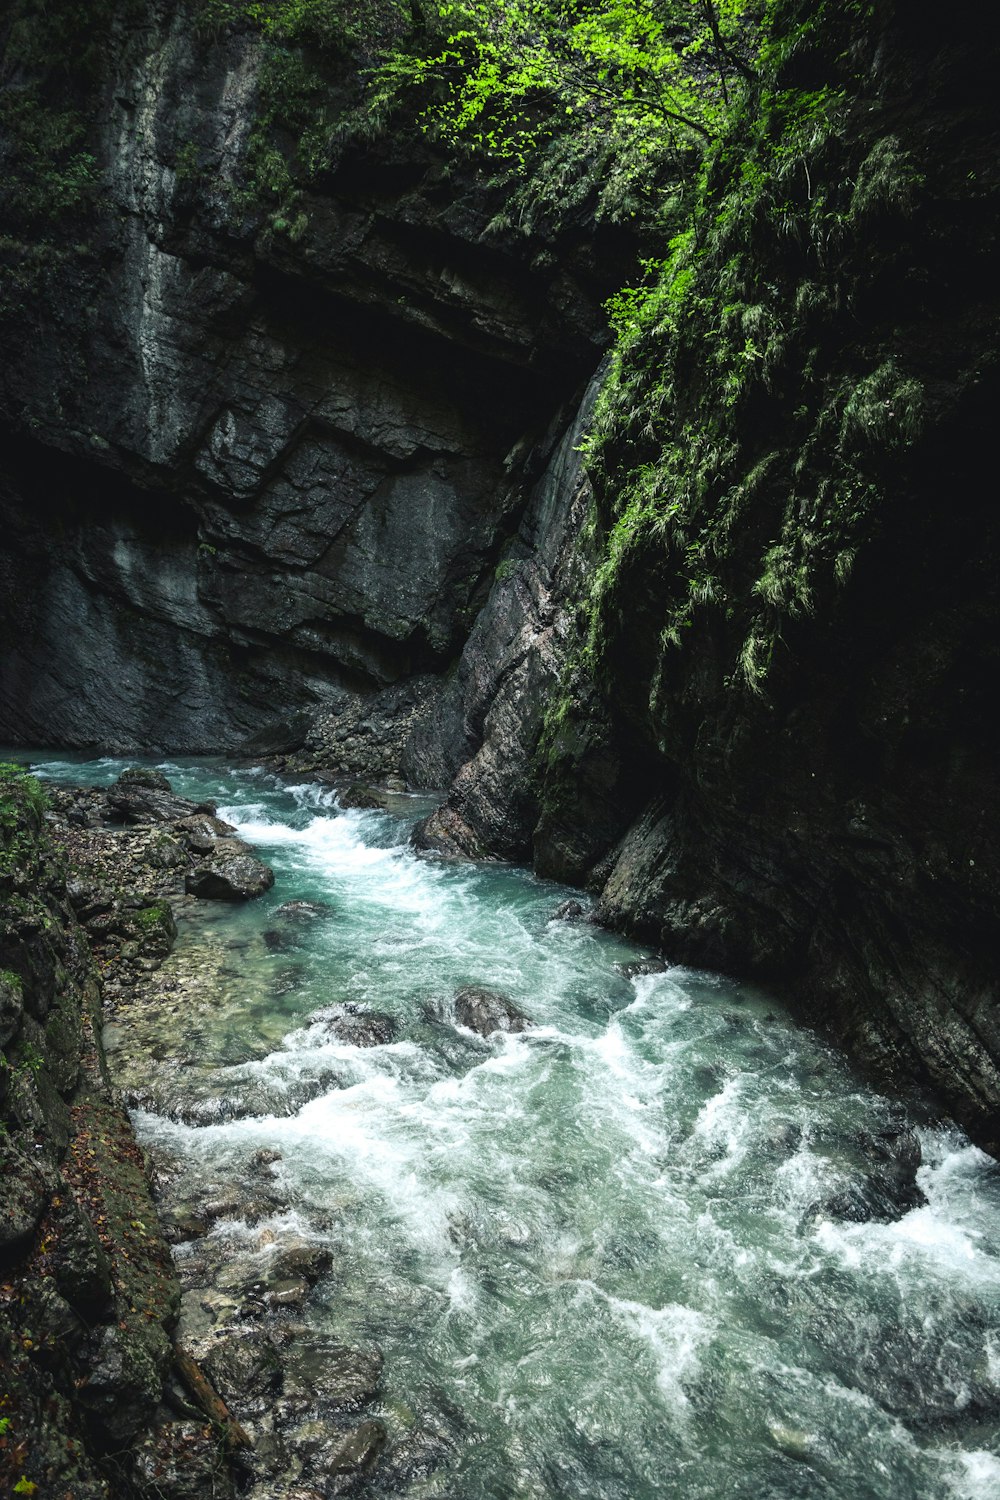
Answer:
[{"xmin": 0, "ymin": 5, "xmax": 615, "ymax": 762}]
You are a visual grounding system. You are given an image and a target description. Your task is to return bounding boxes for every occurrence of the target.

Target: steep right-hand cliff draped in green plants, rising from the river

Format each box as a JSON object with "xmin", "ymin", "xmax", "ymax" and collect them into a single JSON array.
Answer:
[{"xmin": 413, "ymin": 5, "xmax": 1000, "ymax": 1154}]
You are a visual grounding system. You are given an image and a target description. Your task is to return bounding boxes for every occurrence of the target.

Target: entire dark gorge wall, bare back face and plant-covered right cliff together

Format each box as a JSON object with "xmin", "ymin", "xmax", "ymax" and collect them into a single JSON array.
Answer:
[{"xmin": 0, "ymin": 0, "xmax": 1000, "ymax": 1152}]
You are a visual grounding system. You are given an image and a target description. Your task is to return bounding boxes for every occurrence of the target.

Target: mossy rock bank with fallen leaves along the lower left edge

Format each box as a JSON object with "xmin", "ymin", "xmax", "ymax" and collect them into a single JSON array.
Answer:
[{"xmin": 0, "ymin": 767, "xmax": 187, "ymax": 1500}]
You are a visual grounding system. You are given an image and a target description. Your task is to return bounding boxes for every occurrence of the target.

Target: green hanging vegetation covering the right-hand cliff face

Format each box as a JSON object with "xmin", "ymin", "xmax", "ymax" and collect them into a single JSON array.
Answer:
[{"xmin": 586, "ymin": 0, "xmax": 924, "ymax": 717}]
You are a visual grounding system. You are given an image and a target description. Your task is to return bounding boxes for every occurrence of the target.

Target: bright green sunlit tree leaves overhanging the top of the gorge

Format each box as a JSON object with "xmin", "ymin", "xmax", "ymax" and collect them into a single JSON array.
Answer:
[{"xmin": 381, "ymin": 0, "xmax": 754, "ymax": 165}]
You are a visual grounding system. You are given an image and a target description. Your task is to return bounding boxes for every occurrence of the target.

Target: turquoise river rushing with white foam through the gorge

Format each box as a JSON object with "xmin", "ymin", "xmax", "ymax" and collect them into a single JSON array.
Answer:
[{"xmin": 23, "ymin": 761, "xmax": 1000, "ymax": 1500}]
